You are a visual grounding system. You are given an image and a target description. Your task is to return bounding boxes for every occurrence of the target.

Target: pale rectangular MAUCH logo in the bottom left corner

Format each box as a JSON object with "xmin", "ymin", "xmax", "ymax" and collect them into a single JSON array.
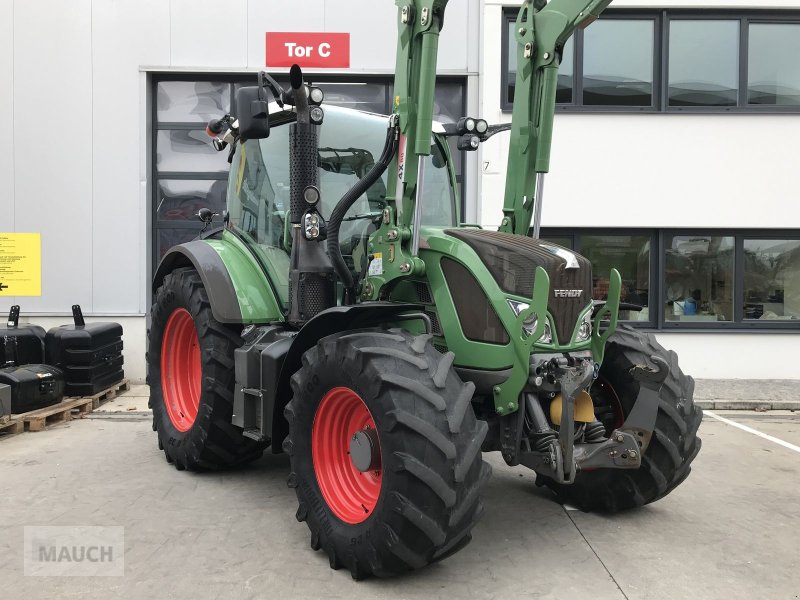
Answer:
[{"xmin": 24, "ymin": 526, "xmax": 125, "ymax": 577}]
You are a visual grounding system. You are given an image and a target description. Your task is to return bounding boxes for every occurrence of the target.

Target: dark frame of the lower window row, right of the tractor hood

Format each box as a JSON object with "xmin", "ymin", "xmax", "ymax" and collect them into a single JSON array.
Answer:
[{"xmin": 541, "ymin": 227, "xmax": 800, "ymax": 334}]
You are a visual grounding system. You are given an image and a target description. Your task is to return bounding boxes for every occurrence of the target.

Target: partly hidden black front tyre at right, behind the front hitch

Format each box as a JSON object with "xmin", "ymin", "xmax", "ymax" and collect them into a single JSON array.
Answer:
[{"xmin": 537, "ymin": 325, "xmax": 703, "ymax": 513}]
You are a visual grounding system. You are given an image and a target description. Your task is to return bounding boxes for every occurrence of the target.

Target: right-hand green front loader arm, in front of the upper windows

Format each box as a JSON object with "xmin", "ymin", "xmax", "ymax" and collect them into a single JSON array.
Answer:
[{"xmin": 500, "ymin": 0, "xmax": 611, "ymax": 235}]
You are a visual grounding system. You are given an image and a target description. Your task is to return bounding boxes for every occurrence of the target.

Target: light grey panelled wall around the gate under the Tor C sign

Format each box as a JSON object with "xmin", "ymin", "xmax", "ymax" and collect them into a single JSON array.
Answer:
[{"xmin": 0, "ymin": 0, "xmax": 480, "ymax": 381}]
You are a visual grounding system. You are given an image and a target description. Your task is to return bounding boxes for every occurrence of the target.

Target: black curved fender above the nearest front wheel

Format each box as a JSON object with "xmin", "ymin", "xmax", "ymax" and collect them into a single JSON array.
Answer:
[{"xmin": 270, "ymin": 302, "xmax": 423, "ymax": 454}]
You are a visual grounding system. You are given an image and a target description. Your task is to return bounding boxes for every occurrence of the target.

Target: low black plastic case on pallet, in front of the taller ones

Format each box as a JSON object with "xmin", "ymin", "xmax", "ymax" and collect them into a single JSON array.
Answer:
[{"xmin": 0, "ymin": 365, "xmax": 64, "ymax": 414}]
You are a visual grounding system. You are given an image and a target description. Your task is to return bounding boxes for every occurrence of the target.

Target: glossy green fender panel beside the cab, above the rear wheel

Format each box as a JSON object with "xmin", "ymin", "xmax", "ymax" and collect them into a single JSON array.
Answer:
[{"xmin": 206, "ymin": 231, "xmax": 288, "ymax": 323}]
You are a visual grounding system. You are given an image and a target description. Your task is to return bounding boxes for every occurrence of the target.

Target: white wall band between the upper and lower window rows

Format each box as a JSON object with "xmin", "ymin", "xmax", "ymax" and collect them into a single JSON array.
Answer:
[{"xmin": 481, "ymin": 113, "xmax": 800, "ymax": 228}]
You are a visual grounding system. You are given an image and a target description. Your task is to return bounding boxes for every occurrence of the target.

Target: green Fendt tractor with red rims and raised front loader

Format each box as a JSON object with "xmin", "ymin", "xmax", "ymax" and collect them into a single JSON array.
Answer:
[{"xmin": 148, "ymin": 0, "xmax": 702, "ymax": 578}]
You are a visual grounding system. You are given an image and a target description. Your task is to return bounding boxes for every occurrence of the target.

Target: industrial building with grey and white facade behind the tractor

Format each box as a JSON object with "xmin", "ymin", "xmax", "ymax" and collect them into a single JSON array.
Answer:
[{"xmin": 0, "ymin": 0, "xmax": 800, "ymax": 380}]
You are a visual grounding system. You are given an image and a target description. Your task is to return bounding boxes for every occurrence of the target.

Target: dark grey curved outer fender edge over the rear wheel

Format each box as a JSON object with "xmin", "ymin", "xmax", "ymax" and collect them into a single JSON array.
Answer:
[{"xmin": 153, "ymin": 240, "xmax": 277, "ymax": 323}]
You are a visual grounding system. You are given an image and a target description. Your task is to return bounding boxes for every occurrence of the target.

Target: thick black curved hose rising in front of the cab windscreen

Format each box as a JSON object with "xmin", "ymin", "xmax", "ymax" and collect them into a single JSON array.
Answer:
[{"xmin": 327, "ymin": 120, "xmax": 397, "ymax": 302}]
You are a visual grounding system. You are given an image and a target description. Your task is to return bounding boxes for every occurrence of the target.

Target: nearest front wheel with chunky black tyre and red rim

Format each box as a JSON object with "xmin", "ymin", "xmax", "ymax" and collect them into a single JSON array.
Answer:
[{"xmin": 284, "ymin": 330, "xmax": 491, "ymax": 579}]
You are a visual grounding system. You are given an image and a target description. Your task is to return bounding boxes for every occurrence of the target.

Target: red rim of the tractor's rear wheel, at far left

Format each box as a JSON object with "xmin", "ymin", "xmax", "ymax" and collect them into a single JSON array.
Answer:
[{"xmin": 161, "ymin": 308, "xmax": 203, "ymax": 431}]
